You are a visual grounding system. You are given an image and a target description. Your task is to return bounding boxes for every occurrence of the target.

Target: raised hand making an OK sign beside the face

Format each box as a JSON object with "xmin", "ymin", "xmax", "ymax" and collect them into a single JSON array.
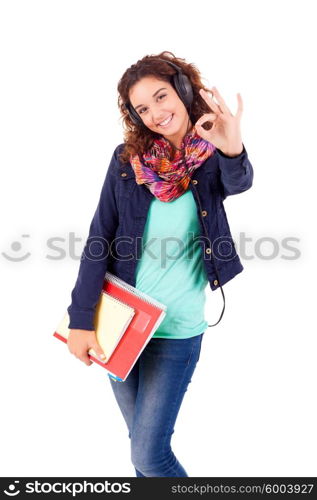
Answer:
[{"xmin": 195, "ymin": 87, "xmax": 243, "ymax": 156}]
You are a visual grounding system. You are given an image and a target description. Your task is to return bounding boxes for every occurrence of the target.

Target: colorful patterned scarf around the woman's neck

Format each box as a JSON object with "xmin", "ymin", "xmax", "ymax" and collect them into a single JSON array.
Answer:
[{"xmin": 130, "ymin": 128, "xmax": 216, "ymax": 202}]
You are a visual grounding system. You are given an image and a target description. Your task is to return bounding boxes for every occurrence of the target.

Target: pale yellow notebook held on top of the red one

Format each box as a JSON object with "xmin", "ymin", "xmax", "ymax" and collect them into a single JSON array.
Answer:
[{"xmin": 56, "ymin": 291, "xmax": 135, "ymax": 362}]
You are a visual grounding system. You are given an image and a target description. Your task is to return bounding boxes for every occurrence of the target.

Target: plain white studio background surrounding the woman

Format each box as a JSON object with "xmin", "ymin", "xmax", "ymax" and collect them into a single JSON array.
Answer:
[{"xmin": 0, "ymin": 0, "xmax": 317, "ymax": 477}]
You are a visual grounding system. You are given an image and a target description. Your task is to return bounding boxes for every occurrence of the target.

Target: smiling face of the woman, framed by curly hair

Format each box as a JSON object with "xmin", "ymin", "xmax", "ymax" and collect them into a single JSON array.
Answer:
[{"xmin": 129, "ymin": 76, "xmax": 192, "ymax": 148}]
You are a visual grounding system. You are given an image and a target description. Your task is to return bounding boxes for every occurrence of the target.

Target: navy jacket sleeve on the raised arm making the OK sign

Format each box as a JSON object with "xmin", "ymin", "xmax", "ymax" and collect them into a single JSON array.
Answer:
[{"xmin": 216, "ymin": 144, "xmax": 253, "ymax": 199}]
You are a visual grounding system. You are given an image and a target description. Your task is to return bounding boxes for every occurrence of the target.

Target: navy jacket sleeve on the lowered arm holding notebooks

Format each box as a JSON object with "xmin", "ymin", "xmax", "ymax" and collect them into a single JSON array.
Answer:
[{"xmin": 67, "ymin": 146, "xmax": 119, "ymax": 330}]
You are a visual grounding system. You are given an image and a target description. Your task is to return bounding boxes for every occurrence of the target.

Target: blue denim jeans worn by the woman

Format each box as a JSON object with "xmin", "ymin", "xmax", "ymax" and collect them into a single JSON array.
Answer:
[{"xmin": 109, "ymin": 332, "xmax": 204, "ymax": 477}]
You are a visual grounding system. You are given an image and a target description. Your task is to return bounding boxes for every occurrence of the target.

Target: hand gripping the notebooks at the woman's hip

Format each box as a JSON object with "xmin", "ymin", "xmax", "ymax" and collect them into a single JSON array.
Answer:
[{"xmin": 67, "ymin": 329, "xmax": 105, "ymax": 366}]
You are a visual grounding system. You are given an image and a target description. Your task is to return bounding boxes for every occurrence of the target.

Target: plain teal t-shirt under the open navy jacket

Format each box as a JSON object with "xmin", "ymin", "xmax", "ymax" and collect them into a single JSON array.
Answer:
[{"xmin": 135, "ymin": 189, "xmax": 208, "ymax": 339}]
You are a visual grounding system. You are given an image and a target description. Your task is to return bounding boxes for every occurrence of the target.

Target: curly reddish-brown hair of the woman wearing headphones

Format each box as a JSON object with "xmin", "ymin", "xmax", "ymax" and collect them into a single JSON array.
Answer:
[{"xmin": 117, "ymin": 50, "xmax": 211, "ymax": 162}]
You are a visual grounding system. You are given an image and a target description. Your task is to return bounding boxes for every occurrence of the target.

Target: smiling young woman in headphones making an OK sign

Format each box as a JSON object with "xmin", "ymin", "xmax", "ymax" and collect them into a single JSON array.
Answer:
[{"xmin": 68, "ymin": 51, "xmax": 253, "ymax": 477}]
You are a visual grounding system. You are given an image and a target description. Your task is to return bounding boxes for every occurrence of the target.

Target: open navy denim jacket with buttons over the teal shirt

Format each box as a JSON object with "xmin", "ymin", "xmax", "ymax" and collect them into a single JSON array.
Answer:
[{"xmin": 67, "ymin": 143, "xmax": 253, "ymax": 330}]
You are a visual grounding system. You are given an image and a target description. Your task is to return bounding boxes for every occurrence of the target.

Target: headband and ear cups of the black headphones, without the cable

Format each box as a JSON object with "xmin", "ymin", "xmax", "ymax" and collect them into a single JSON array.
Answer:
[{"xmin": 125, "ymin": 58, "xmax": 194, "ymax": 127}]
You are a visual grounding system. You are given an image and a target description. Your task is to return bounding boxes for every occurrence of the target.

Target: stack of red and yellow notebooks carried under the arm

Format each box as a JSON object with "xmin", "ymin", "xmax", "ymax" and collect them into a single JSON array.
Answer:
[{"xmin": 53, "ymin": 272, "xmax": 167, "ymax": 382}]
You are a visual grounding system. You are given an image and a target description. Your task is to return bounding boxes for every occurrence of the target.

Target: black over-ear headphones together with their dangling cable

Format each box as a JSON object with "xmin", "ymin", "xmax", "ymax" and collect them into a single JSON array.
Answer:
[{"xmin": 125, "ymin": 58, "xmax": 226, "ymax": 327}]
